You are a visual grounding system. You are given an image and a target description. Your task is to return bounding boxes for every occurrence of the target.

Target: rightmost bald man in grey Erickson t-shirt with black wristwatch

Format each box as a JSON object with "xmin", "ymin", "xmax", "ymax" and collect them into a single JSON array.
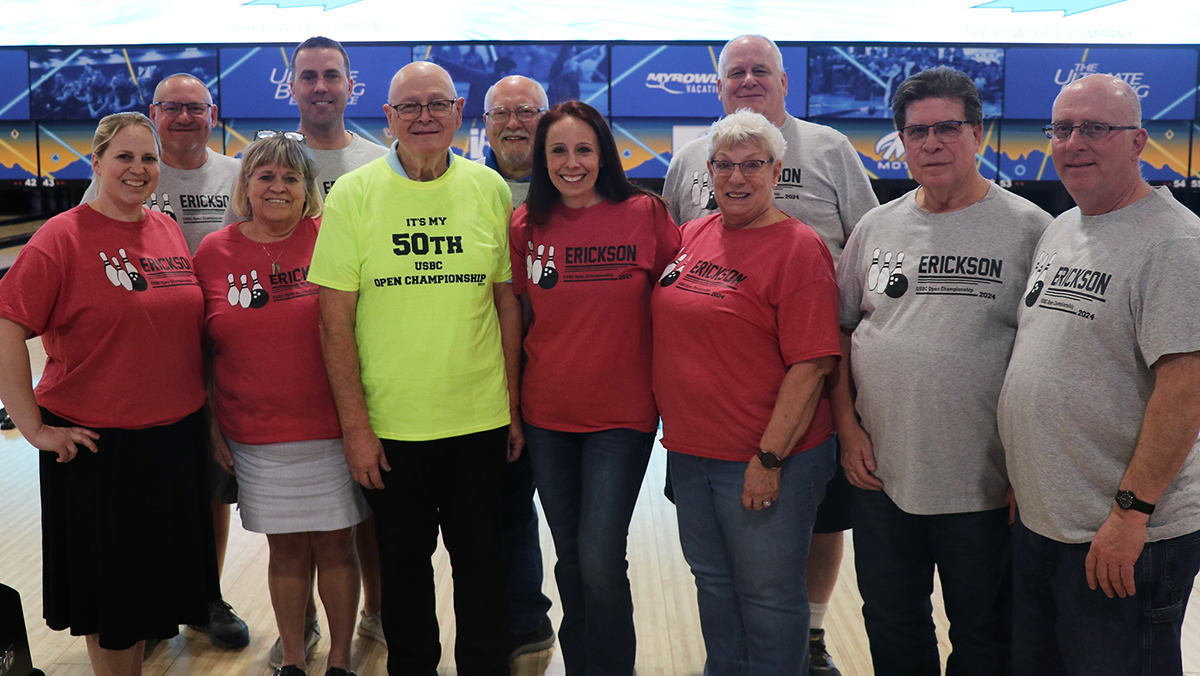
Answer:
[{"xmin": 1000, "ymin": 74, "xmax": 1200, "ymax": 675}]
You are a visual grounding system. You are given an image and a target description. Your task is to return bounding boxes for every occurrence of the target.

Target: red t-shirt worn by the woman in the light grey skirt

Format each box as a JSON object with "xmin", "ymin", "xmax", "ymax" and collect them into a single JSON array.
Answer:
[{"xmin": 196, "ymin": 219, "xmax": 342, "ymax": 444}]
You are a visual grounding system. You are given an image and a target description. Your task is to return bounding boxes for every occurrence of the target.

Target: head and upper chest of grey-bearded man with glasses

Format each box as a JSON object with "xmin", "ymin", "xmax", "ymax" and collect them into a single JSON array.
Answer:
[{"xmin": 484, "ymin": 76, "xmax": 550, "ymax": 209}]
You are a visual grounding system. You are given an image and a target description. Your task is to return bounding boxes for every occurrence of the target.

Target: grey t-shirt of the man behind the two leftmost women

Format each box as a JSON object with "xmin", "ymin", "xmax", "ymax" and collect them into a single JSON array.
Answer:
[{"xmin": 83, "ymin": 148, "xmax": 241, "ymax": 253}]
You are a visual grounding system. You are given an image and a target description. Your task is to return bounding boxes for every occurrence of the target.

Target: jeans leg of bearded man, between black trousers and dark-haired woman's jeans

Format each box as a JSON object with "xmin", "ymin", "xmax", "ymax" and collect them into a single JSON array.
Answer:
[{"xmin": 500, "ymin": 453, "xmax": 550, "ymax": 635}]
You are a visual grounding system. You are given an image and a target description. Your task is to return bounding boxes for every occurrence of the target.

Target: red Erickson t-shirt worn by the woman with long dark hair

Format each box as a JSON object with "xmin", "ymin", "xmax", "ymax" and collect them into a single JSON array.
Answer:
[{"xmin": 509, "ymin": 196, "xmax": 679, "ymax": 432}]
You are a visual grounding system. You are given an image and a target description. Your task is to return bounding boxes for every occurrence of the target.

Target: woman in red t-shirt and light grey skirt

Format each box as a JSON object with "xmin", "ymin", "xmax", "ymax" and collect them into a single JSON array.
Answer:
[{"xmin": 196, "ymin": 131, "xmax": 368, "ymax": 676}]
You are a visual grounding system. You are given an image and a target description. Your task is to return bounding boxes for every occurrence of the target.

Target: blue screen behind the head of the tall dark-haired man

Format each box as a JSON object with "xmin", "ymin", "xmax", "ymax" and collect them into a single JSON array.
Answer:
[{"xmin": 221, "ymin": 44, "xmax": 412, "ymax": 120}]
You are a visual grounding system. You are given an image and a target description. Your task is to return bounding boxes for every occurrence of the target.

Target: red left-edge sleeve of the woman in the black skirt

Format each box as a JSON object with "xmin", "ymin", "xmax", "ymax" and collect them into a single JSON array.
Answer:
[{"xmin": 0, "ymin": 245, "xmax": 62, "ymax": 335}]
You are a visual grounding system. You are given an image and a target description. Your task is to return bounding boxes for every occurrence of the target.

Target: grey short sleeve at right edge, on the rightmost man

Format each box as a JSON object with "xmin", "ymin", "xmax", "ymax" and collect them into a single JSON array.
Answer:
[{"xmin": 1130, "ymin": 238, "xmax": 1200, "ymax": 366}]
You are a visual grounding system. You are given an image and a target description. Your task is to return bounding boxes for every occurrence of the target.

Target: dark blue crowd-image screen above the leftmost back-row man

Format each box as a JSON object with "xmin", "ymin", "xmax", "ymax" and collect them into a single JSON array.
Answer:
[{"xmin": 28, "ymin": 47, "xmax": 217, "ymax": 120}]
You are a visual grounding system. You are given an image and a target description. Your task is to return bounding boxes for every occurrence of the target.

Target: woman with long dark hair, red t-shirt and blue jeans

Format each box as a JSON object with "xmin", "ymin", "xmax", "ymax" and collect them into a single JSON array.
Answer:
[{"xmin": 510, "ymin": 101, "xmax": 679, "ymax": 676}]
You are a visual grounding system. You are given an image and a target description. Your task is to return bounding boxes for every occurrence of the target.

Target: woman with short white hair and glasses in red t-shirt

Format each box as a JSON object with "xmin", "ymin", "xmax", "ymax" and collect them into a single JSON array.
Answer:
[{"xmin": 653, "ymin": 110, "xmax": 841, "ymax": 676}]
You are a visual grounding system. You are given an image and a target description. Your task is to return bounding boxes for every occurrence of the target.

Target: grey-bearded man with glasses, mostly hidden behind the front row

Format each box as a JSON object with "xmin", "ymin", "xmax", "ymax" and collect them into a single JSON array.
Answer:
[{"xmin": 482, "ymin": 76, "xmax": 554, "ymax": 659}]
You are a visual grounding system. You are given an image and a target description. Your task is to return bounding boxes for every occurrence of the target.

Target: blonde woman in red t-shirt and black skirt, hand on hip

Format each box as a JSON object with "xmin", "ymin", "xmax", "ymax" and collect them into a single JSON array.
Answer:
[{"xmin": 0, "ymin": 113, "xmax": 221, "ymax": 675}]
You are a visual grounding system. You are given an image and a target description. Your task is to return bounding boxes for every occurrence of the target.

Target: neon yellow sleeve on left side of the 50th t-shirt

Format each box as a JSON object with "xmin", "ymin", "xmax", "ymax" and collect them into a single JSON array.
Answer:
[{"xmin": 308, "ymin": 181, "xmax": 362, "ymax": 292}]
